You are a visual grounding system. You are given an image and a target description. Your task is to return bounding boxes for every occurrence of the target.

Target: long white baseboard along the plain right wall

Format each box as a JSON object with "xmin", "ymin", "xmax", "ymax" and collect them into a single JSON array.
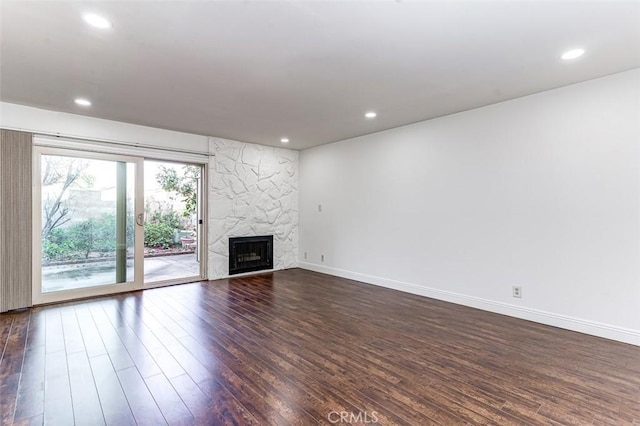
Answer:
[{"xmin": 298, "ymin": 261, "xmax": 640, "ymax": 346}]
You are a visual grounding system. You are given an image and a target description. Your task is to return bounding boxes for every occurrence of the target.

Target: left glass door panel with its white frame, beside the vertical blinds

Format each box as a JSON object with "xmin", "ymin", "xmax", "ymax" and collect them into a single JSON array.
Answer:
[{"xmin": 34, "ymin": 147, "xmax": 144, "ymax": 303}]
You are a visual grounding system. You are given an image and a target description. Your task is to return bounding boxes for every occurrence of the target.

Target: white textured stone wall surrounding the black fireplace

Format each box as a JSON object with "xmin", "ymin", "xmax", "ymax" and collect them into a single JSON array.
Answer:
[{"xmin": 208, "ymin": 138, "xmax": 298, "ymax": 279}]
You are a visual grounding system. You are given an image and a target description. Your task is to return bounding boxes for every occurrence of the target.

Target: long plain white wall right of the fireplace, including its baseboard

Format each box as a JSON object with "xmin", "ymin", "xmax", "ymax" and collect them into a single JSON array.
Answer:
[{"xmin": 299, "ymin": 70, "xmax": 640, "ymax": 344}]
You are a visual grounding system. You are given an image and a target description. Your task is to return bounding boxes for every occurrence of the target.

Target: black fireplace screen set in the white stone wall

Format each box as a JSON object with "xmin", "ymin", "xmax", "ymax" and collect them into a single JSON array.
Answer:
[{"xmin": 229, "ymin": 235, "xmax": 273, "ymax": 275}]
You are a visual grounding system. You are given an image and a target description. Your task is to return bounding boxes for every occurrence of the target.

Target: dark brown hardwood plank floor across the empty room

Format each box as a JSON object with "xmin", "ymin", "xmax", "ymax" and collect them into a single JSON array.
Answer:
[{"xmin": 0, "ymin": 269, "xmax": 640, "ymax": 425}]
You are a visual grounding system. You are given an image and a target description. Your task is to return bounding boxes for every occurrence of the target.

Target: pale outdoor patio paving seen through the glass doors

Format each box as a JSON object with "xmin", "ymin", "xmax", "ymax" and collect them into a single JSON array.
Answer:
[{"xmin": 42, "ymin": 253, "xmax": 200, "ymax": 292}]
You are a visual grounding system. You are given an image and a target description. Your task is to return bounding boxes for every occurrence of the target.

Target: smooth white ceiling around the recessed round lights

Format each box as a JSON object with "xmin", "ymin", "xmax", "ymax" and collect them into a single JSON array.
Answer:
[{"xmin": 0, "ymin": 0, "xmax": 640, "ymax": 149}]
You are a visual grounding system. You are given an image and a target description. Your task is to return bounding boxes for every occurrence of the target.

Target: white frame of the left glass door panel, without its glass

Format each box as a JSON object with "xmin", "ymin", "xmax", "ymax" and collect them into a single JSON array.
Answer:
[{"xmin": 32, "ymin": 145, "xmax": 144, "ymax": 305}]
